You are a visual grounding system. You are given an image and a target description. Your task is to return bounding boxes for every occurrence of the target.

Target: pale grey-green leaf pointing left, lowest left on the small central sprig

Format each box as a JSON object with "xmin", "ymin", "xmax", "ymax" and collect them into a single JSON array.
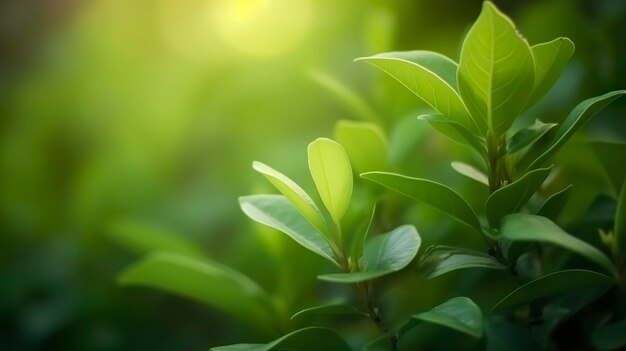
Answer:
[{"xmin": 239, "ymin": 195, "xmax": 340, "ymax": 266}]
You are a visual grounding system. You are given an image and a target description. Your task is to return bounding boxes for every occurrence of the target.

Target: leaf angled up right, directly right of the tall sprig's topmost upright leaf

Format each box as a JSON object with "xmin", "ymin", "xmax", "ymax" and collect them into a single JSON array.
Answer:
[{"xmin": 526, "ymin": 37, "xmax": 574, "ymax": 107}]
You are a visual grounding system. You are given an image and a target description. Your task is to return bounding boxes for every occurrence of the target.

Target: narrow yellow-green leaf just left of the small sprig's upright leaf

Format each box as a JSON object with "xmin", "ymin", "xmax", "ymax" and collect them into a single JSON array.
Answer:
[{"xmin": 252, "ymin": 161, "xmax": 328, "ymax": 235}]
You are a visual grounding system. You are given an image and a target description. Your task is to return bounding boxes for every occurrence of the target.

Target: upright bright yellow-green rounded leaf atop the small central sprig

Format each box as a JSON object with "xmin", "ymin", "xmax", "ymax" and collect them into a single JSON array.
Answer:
[{"xmin": 308, "ymin": 138, "xmax": 352, "ymax": 224}]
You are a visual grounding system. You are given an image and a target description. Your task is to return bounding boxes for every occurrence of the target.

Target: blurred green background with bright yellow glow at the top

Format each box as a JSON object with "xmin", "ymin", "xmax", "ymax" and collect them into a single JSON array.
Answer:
[{"xmin": 0, "ymin": 0, "xmax": 626, "ymax": 350}]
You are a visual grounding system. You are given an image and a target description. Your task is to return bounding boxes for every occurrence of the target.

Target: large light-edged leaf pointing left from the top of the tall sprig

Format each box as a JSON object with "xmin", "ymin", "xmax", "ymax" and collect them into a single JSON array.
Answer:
[{"xmin": 355, "ymin": 51, "xmax": 478, "ymax": 131}]
